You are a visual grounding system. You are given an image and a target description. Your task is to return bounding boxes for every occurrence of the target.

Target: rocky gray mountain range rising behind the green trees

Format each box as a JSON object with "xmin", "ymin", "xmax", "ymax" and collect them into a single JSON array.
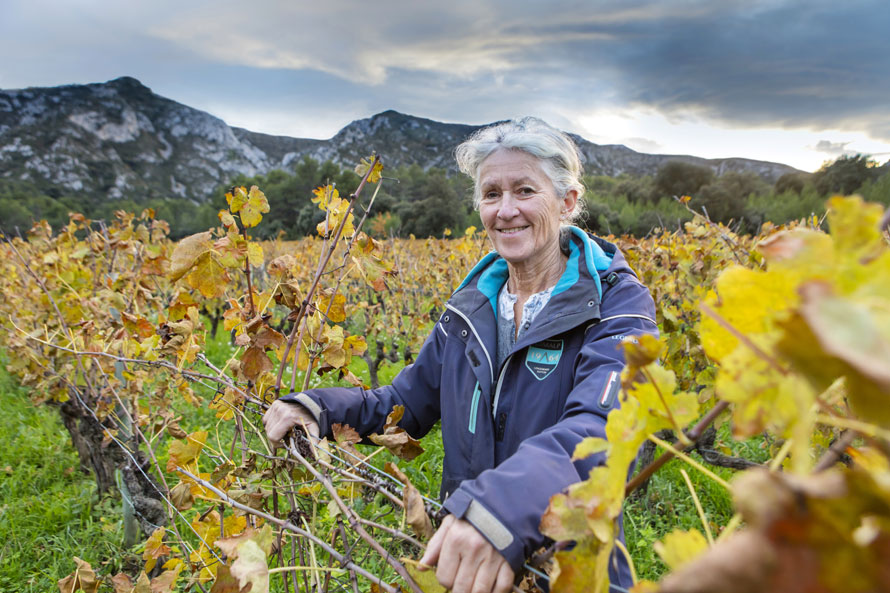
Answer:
[{"xmin": 0, "ymin": 77, "xmax": 797, "ymax": 201}]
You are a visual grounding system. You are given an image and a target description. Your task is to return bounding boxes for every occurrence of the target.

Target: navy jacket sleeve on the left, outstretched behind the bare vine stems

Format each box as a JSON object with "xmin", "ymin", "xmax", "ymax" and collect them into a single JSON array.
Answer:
[{"xmin": 281, "ymin": 320, "xmax": 445, "ymax": 438}]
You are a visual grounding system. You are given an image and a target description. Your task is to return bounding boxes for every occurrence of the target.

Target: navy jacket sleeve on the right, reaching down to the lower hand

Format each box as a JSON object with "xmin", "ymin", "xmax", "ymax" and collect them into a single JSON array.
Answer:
[{"xmin": 445, "ymin": 278, "xmax": 658, "ymax": 570}]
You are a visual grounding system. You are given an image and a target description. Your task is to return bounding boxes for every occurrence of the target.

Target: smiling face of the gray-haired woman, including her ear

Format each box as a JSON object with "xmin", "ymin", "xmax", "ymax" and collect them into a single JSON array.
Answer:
[{"xmin": 479, "ymin": 149, "xmax": 578, "ymax": 269}]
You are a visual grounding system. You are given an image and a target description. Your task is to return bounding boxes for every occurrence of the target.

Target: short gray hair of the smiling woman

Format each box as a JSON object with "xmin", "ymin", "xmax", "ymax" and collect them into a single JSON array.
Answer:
[{"xmin": 454, "ymin": 117, "xmax": 584, "ymax": 221}]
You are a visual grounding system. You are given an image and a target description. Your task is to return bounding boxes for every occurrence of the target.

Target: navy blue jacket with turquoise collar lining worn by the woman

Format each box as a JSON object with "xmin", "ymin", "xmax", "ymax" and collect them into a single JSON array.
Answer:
[{"xmin": 286, "ymin": 227, "xmax": 658, "ymax": 586}]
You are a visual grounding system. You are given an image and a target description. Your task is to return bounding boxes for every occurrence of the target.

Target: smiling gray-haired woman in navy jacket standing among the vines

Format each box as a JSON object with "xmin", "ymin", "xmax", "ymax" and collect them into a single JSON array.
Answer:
[{"xmin": 264, "ymin": 118, "xmax": 657, "ymax": 593}]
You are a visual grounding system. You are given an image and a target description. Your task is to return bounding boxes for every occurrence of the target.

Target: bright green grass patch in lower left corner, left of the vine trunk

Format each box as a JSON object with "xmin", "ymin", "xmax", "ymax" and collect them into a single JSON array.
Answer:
[{"xmin": 0, "ymin": 357, "xmax": 130, "ymax": 593}]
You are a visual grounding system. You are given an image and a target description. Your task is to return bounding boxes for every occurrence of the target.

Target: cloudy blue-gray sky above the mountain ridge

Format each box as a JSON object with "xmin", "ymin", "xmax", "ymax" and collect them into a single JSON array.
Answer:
[{"xmin": 0, "ymin": 0, "xmax": 890, "ymax": 170}]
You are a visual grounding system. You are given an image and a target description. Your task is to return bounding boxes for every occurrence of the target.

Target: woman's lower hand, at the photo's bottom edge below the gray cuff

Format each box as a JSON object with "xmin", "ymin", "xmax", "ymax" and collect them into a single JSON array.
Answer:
[{"xmin": 420, "ymin": 515, "xmax": 514, "ymax": 593}]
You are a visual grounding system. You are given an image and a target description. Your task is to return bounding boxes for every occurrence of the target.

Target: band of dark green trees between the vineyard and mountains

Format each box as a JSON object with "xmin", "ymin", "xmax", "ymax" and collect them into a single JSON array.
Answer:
[{"xmin": 0, "ymin": 154, "xmax": 890, "ymax": 239}]
